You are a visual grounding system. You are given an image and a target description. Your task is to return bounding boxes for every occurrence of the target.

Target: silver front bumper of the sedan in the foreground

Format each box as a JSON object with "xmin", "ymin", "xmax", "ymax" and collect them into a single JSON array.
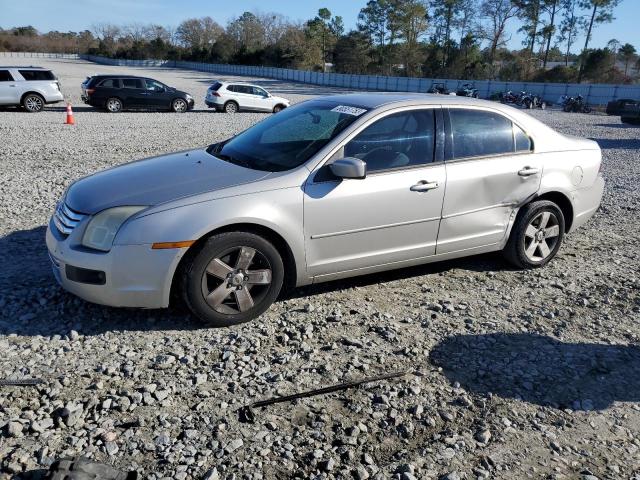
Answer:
[{"xmin": 46, "ymin": 217, "xmax": 184, "ymax": 308}]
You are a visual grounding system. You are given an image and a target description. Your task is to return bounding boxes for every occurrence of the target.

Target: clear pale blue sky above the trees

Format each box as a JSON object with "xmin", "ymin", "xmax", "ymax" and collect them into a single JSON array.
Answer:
[{"xmin": 0, "ymin": 0, "xmax": 640, "ymax": 50}]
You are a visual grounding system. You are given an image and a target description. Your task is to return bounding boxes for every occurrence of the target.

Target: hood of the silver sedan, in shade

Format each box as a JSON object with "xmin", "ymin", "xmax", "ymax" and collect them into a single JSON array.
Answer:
[{"xmin": 65, "ymin": 149, "xmax": 271, "ymax": 214}]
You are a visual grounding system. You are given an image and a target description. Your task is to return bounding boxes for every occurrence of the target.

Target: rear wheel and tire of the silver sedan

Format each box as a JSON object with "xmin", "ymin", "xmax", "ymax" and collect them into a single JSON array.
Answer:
[{"xmin": 504, "ymin": 200, "xmax": 565, "ymax": 269}]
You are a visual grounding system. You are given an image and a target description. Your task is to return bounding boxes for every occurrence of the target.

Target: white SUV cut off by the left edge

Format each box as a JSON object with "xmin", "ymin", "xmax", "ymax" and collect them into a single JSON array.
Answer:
[{"xmin": 0, "ymin": 67, "xmax": 64, "ymax": 113}]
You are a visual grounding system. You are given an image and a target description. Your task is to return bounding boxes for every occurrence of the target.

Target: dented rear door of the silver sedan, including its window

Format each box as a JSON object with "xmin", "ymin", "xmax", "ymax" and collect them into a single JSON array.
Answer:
[{"xmin": 437, "ymin": 108, "xmax": 542, "ymax": 255}]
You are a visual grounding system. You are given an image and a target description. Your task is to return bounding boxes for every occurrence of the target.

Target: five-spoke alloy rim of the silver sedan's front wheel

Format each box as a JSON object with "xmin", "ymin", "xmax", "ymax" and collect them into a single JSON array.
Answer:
[{"xmin": 202, "ymin": 246, "xmax": 272, "ymax": 315}]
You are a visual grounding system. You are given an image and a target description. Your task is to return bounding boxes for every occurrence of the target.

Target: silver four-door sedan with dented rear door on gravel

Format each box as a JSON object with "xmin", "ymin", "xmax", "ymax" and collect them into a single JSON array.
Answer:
[{"xmin": 47, "ymin": 93, "xmax": 604, "ymax": 326}]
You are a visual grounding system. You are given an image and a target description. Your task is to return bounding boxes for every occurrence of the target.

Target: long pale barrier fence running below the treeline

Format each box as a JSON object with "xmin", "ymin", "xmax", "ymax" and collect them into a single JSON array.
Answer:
[{"xmin": 0, "ymin": 52, "xmax": 640, "ymax": 105}]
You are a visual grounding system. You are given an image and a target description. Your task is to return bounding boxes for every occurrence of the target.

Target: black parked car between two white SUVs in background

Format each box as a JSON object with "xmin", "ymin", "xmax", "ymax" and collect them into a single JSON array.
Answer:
[{"xmin": 81, "ymin": 75, "xmax": 194, "ymax": 113}]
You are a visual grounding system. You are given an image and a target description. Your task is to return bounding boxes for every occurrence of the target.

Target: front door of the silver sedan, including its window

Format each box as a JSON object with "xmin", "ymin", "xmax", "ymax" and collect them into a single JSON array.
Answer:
[{"xmin": 304, "ymin": 109, "xmax": 446, "ymax": 277}]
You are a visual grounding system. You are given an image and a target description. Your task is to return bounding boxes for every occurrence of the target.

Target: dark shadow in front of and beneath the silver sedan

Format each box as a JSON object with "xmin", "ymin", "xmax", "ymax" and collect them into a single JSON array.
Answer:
[{"xmin": 0, "ymin": 226, "xmax": 512, "ymax": 336}]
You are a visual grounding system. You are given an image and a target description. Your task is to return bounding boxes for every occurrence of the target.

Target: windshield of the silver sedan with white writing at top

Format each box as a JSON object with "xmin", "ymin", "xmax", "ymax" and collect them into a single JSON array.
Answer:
[{"xmin": 207, "ymin": 100, "xmax": 367, "ymax": 172}]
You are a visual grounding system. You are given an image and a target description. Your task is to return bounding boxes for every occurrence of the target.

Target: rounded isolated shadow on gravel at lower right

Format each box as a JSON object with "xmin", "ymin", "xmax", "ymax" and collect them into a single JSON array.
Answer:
[{"xmin": 430, "ymin": 333, "xmax": 640, "ymax": 410}]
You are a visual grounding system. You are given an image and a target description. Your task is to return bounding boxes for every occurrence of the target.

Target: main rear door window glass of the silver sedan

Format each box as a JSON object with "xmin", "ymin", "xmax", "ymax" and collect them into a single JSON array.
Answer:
[{"xmin": 449, "ymin": 108, "xmax": 515, "ymax": 158}]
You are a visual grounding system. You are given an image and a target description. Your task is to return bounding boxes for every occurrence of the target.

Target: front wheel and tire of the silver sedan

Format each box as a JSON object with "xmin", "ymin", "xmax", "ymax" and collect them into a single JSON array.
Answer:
[{"xmin": 180, "ymin": 232, "xmax": 284, "ymax": 327}]
